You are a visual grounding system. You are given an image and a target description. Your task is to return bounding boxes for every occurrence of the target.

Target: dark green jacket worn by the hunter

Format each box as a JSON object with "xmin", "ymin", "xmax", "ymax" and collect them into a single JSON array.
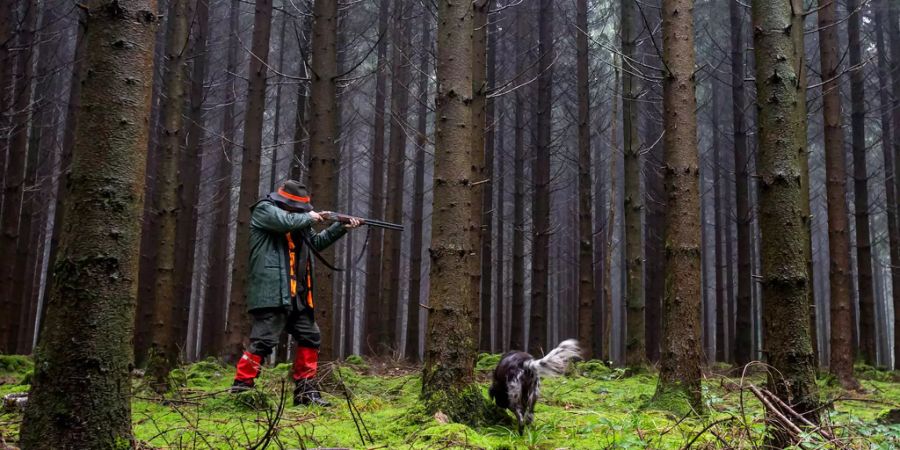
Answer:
[{"xmin": 247, "ymin": 200, "xmax": 347, "ymax": 311}]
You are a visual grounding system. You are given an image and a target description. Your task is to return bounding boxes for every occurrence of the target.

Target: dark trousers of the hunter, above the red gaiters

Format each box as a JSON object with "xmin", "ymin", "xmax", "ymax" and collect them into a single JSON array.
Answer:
[{"xmin": 249, "ymin": 300, "xmax": 322, "ymax": 358}]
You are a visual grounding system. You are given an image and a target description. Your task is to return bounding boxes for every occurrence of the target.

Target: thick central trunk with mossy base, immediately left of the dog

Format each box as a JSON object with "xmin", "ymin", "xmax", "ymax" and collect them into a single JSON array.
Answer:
[{"xmin": 422, "ymin": 2, "xmax": 484, "ymax": 422}]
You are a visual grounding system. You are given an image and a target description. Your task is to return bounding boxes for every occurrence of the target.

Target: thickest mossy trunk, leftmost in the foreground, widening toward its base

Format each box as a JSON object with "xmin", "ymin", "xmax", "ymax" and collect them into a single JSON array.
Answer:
[{"xmin": 21, "ymin": 0, "xmax": 156, "ymax": 442}]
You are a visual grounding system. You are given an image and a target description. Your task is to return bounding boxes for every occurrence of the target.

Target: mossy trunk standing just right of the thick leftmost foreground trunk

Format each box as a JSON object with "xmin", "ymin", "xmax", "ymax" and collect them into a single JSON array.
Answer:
[{"xmin": 147, "ymin": 0, "xmax": 190, "ymax": 391}]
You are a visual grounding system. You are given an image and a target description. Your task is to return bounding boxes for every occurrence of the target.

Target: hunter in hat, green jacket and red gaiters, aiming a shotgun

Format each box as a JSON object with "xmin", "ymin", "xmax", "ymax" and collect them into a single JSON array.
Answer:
[{"xmin": 231, "ymin": 180, "xmax": 362, "ymax": 406}]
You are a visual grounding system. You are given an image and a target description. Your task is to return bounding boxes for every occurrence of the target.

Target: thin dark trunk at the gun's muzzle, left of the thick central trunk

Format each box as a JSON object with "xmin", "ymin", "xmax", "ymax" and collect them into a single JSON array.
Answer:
[{"xmin": 406, "ymin": 10, "xmax": 431, "ymax": 361}]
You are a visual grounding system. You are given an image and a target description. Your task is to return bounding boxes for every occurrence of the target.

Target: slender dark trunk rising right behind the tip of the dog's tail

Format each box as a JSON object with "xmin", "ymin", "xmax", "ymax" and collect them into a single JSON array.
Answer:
[{"xmin": 576, "ymin": 0, "xmax": 597, "ymax": 359}]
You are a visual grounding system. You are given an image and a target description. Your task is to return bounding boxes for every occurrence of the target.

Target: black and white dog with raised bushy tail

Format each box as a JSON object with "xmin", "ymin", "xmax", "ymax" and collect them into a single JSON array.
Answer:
[{"xmin": 488, "ymin": 339, "xmax": 581, "ymax": 433}]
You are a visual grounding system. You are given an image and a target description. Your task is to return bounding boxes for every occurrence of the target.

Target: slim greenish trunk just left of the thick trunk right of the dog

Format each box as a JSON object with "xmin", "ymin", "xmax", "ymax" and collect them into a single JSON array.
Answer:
[{"xmin": 621, "ymin": 0, "xmax": 647, "ymax": 367}]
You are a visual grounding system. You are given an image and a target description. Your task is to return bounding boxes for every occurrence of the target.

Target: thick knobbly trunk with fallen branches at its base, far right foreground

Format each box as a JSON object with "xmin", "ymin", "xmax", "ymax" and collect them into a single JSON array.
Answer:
[{"xmin": 752, "ymin": 0, "xmax": 818, "ymax": 434}]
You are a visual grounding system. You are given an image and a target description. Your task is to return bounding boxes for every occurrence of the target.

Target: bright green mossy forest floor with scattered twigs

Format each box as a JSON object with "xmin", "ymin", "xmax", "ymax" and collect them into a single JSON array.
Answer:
[{"xmin": 0, "ymin": 355, "xmax": 900, "ymax": 449}]
